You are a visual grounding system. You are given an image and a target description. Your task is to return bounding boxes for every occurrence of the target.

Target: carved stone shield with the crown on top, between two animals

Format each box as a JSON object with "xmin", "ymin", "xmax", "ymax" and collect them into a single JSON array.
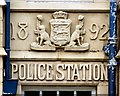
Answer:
[{"xmin": 50, "ymin": 11, "xmax": 72, "ymax": 46}]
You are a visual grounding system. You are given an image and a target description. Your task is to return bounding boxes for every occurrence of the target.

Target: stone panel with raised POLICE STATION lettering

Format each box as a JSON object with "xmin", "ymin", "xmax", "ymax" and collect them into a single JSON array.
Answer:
[{"xmin": 11, "ymin": 61, "xmax": 108, "ymax": 84}]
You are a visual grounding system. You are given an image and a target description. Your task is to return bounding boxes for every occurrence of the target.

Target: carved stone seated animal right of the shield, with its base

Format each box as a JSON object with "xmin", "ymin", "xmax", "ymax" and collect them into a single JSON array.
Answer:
[{"xmin": 65, "ymin": 15, "xmax": 89, "ymax": 51}]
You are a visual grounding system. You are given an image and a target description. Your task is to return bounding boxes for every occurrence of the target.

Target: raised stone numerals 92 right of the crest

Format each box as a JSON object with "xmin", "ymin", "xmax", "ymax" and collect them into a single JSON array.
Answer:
[{"xmin": 89, "ymin": 23, "xmax": 109, "ymax": 41}]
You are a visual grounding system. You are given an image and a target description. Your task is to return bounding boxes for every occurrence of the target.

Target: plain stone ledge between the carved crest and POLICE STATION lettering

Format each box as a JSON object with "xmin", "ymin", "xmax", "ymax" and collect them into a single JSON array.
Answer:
[{"xmin": 10, "ymin": 51, "xmax": 108, "ymax": 61}]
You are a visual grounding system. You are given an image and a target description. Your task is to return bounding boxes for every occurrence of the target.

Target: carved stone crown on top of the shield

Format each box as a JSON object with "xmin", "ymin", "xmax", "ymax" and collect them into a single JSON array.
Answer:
[{"xmin": 53, "ymin": 11, "xmax": 68, "ymax": 19}]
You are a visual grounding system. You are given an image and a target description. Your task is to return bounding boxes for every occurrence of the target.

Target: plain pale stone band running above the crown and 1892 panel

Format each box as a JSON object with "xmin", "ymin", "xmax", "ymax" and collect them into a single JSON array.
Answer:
[{"xmin": 11, "ymin": 1, "xmax": 110, "ymax": 12}]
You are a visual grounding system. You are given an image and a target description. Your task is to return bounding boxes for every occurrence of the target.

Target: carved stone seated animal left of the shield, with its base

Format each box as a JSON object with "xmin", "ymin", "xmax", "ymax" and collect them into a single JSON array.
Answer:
[{"xmin": 31, "ymin": 15, "xmax": 55, "ymax": 50}]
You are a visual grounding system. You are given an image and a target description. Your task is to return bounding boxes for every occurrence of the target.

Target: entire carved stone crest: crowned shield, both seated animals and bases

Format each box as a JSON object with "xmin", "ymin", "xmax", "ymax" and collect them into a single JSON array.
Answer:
[{"xmin": 31, "ymin": 11, "xmax": 89, "ymax": 51}]
